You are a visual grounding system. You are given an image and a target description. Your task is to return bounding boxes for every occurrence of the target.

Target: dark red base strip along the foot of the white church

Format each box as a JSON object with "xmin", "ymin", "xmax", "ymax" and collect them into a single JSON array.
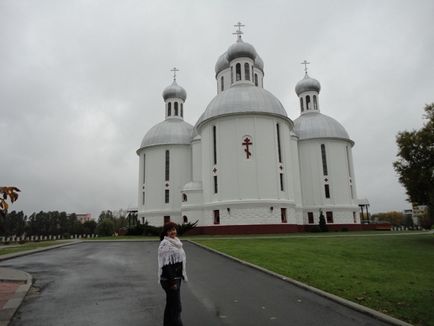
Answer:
[{"xmin": 187, "ymin": 223, "xmax": 391, "ymax": 235}]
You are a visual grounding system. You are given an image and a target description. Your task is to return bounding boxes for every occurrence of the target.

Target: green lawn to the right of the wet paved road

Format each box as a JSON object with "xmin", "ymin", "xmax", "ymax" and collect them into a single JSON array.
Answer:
[{"xmin": 195, "ymin": 233, "xmax": 434, "ymax": 325}]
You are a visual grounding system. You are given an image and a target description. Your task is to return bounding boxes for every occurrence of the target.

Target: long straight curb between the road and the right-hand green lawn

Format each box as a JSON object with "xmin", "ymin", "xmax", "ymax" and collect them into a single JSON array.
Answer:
[{"xmin": 190, "ymin": 240, "xmax": 413, "ymax": 326}]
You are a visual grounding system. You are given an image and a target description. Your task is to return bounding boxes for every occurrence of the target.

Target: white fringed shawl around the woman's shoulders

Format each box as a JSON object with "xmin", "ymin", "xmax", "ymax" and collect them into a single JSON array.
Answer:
[{"xmin": 158, "ymin": 237, "xmax": 188, "ymax": 282}]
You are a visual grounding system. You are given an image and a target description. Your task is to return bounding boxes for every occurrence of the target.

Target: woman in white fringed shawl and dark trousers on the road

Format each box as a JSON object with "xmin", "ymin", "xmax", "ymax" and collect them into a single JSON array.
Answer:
[{"xmin": 158, "ymin": 222, "xmax": 187, "ymax": 326}]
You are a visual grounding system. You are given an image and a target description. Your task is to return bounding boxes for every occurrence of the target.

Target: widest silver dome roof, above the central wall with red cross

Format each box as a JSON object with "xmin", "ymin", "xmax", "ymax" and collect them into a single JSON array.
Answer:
[{"xmin": 195, "ymin": 83, "xmax": 289, "ymax": 128}]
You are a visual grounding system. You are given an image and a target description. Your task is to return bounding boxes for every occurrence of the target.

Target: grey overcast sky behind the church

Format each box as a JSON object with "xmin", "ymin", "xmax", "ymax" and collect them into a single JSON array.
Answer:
[{"xmin": 0, "ymin": 0, "xmax": 434, "ymax": 218}]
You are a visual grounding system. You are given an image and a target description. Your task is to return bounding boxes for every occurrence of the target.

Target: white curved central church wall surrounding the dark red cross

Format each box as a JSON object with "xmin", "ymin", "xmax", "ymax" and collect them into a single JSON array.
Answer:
[{"xmin": 200, "ymin": 115, "xmax": 293, "ymax": 203}]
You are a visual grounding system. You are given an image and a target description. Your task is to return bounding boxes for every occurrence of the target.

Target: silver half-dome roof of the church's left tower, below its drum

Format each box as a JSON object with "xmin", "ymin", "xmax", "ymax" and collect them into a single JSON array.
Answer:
[{"xmin": 139, "ymin": 118, "xmax": 193, "ymax": 150}]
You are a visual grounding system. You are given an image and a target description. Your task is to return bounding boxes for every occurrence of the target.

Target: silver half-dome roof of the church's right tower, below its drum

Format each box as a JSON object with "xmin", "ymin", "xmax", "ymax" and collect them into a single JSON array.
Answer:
[{"xmin": 294, "ymin": 112, "xmax": 354, "ymax": 144}]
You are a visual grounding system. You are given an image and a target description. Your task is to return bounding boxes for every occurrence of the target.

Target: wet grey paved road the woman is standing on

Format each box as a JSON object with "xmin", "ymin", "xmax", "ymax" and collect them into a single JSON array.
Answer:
[{"xmin": 0, "ymin": 242, "xmax": 387, "ymax": 326}]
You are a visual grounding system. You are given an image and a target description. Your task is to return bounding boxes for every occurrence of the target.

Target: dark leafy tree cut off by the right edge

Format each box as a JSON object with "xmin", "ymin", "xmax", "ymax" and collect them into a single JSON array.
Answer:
[{"xmin": 393, "ymin": 103, "xmax": 434, "ymax": 227}]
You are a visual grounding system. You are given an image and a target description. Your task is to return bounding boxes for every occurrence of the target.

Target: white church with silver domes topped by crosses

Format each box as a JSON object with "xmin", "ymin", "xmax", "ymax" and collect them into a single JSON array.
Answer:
[{"xmin": 137, "ymin": 24, "xmax": 361, "ymax": 234}]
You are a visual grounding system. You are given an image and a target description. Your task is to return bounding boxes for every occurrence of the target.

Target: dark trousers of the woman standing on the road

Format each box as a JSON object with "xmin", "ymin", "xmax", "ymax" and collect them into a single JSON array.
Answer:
[{"xmin": 160, "ymin": 279, "xmax": 182, "ymax": 326}]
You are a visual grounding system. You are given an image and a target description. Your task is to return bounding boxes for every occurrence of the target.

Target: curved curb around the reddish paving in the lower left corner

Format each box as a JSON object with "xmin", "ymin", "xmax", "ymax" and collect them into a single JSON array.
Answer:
[{"xmin": 0, "ymin": 268, "xmax": 33, "ymax": 326}]
